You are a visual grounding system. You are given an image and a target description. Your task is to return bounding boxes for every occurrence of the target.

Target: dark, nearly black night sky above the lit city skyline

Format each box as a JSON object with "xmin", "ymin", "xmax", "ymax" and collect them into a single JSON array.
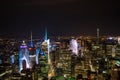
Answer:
[{"xmin": 0, "ymin": 0, "xmax": 120, "ymax": 37}]
